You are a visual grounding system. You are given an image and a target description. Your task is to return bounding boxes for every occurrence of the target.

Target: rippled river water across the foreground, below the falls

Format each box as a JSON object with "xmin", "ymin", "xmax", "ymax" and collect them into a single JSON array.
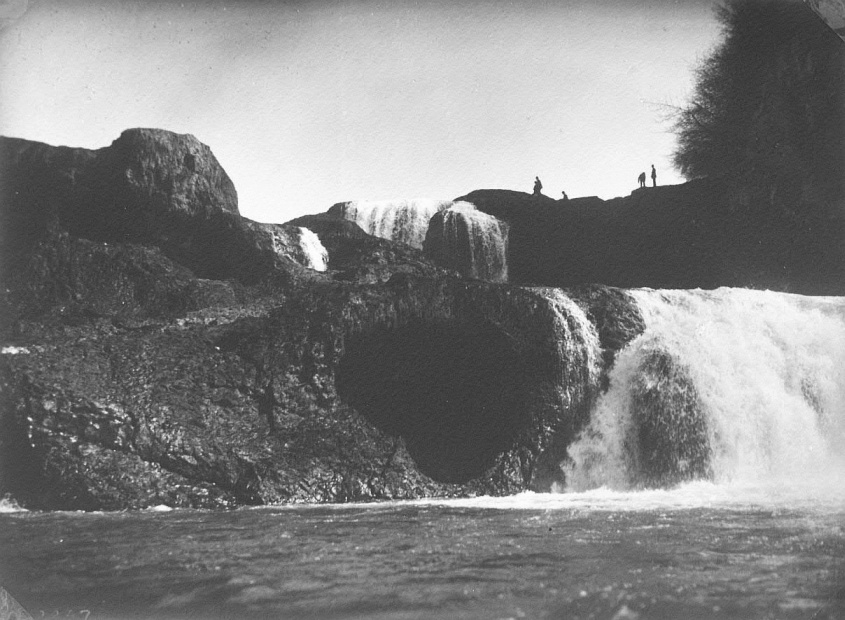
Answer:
[{"xmin": 0, "ymin": 490, "xmax": 845, "ymax": 619}]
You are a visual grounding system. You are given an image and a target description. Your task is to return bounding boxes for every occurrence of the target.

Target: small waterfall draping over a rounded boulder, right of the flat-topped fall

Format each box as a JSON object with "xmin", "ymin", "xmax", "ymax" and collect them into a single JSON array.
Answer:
[{"xmin": 424, "ymin": 202, "xmax": 508, "ymax": 282}]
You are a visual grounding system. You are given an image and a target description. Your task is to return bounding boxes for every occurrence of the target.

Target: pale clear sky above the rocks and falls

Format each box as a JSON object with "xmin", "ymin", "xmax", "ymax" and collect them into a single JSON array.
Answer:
[{"xmin": 0, "ymin": 0, "xmax": 720, "ymax": 223}]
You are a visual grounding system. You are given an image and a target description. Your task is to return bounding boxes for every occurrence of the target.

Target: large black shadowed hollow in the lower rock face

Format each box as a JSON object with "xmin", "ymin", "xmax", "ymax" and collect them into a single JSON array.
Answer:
[{"xmin": 336, "ymin": 321, "xmax": 530, "ymax": 483}]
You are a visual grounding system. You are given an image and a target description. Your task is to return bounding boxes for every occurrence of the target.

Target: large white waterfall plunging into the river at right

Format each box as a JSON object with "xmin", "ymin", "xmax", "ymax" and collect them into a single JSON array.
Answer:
[{"xmin": 563, "ymin": 289, "xmax": 845, "ymax": 491}]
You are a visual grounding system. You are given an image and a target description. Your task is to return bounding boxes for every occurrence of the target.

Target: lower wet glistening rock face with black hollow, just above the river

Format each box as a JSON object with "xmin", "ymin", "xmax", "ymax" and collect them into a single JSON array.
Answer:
[{"xmin": 0, "ymin": 279, "xmax": 632, "ymax": 509}]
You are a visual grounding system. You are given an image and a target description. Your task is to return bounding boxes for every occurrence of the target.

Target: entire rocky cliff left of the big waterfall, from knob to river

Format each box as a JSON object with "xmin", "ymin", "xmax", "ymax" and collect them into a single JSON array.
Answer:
[{"xmin": 0, "ymin": 129, "xmax": 642, "ymax": 510}]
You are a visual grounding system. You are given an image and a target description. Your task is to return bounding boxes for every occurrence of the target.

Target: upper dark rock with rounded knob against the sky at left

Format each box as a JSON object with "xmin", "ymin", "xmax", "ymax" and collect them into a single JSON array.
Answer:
[{"xmin": 0, "ymin": 129, "xmax": 314, "ymax": 283}]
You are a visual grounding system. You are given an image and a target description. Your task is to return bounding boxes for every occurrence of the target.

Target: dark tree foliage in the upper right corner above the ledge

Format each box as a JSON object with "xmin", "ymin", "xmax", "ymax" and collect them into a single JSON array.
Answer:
[{"xmin": 674, "ymin": 0, "xmax": 845, "ymax": 205}]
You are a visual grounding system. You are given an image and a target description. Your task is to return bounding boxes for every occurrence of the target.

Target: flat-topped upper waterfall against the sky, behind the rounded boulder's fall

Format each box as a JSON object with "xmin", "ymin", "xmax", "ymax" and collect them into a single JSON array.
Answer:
[{"xmin": 329, "ymin": 199, "xmax": 452, "ymax": 250}]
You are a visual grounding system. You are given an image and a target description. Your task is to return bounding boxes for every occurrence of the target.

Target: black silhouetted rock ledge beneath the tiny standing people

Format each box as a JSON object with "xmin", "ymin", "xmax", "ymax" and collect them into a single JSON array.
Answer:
[{"xmin": 456, "ymin": 179, "xmax": 845, "ymax": 295}]
